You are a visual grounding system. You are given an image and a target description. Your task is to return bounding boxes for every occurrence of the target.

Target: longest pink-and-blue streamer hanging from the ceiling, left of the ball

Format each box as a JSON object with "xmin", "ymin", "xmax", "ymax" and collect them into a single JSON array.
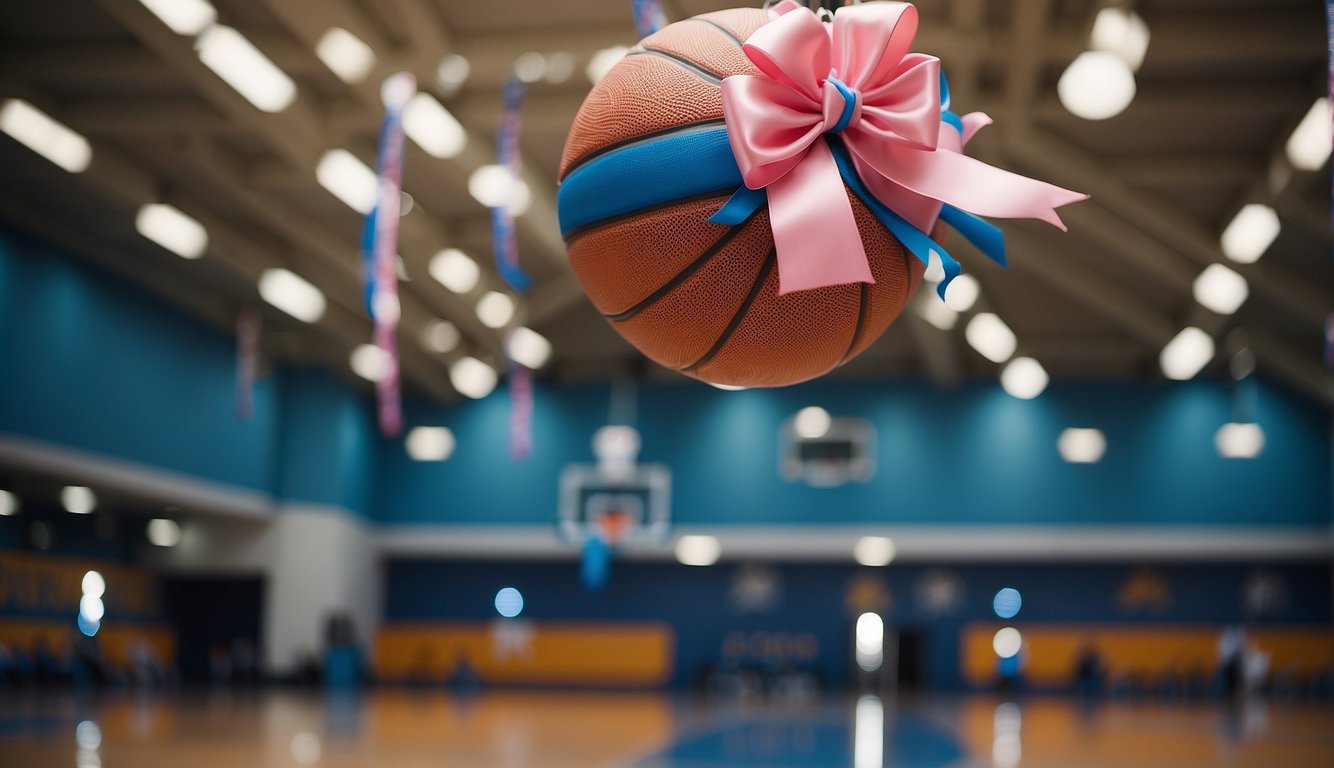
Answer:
[{"xmin": 366, "ymin": 72, "xmax": 416, "ymax": 437}]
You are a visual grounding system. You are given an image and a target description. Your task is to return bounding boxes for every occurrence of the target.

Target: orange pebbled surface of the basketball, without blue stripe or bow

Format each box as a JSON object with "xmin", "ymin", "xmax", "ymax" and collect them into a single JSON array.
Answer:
[{"xmin": 560, "ymin": 9, "xmax": 923, "ymax": 387}]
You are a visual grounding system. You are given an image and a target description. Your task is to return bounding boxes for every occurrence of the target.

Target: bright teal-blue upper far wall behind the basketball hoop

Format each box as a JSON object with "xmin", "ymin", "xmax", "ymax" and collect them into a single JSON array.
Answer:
[{"xmin": 376, "ymin": 381, "xmax": 1331, "ymax": 525}]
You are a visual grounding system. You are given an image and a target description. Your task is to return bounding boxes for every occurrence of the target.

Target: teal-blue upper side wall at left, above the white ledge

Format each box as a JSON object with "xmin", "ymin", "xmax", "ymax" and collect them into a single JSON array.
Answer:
[{"xmin": 0, "ymin": 233, "xmax": 375, "ymax": 513}]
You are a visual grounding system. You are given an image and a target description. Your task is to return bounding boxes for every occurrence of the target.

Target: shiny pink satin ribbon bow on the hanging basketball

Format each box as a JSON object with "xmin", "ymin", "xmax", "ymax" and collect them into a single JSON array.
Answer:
[{"xmin": 723, "ymin": 3, "xmax": 1086, "ymax": 293}]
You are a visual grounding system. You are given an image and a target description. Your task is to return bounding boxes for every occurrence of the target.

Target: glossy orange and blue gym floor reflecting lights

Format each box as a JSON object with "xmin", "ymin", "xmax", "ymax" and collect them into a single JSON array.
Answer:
[{"xmin": 0, "ymin": 689, "xmax": 1334, "ymax": 768}]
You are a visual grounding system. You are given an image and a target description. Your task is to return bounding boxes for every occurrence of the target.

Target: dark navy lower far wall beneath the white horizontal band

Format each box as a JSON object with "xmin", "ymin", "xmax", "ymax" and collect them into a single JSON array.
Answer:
[{"xmin": 384, "ymin": 559, "xmax": 1331, "ymax": 687}]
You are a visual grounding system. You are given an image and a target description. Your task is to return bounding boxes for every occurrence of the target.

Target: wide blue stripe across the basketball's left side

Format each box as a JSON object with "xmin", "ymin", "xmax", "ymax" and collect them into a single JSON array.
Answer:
[{"xmin": 556, "ymin": 128, "xmax": 742, "ymax": 233}]
